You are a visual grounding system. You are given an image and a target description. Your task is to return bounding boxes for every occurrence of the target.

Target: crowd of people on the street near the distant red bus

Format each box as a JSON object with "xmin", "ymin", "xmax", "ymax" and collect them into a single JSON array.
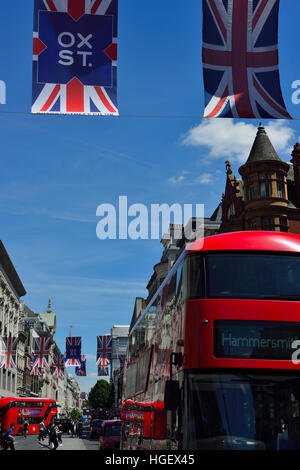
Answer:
[{"xmin": 0, "ymin": 419, "xmax": 83, "ymax": 450}]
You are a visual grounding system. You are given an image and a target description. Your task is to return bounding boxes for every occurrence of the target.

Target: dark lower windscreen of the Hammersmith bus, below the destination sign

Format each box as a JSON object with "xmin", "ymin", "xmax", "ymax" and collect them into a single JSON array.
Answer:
[{"xmin": 184, "ymin": 371, "xmax": 300, "ymax": 450}]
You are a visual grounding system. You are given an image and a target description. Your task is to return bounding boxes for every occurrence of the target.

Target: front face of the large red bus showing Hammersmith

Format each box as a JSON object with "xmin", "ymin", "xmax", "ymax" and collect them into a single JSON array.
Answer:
[{"xmin": 177, "ymin": 232, "xmax": 300, "ymax": 450}]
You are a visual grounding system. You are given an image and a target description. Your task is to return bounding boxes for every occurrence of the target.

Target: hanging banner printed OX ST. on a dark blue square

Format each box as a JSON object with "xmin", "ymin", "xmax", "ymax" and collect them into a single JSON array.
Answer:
[{"xmin": 32, "ymin": 0, "xmax": 118, "ymax": 116}]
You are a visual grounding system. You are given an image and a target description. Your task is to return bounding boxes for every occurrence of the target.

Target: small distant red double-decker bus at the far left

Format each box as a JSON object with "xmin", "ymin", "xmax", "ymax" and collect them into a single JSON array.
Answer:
[{"xmin": 0, "ymin": 397, "xmax": 57, "ymax": 434}]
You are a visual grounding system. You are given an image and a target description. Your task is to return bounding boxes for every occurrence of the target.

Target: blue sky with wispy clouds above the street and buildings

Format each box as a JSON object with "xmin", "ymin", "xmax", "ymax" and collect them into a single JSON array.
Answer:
[{"xmin": 0, "ymin": 0, "xmax": 300, "ymax": 391}]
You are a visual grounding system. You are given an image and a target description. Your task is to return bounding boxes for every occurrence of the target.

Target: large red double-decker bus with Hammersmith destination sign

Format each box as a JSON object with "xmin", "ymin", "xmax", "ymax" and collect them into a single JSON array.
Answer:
[{"xmin": 121, "ymin": 231, "xmax": 300, "ymax": 450}]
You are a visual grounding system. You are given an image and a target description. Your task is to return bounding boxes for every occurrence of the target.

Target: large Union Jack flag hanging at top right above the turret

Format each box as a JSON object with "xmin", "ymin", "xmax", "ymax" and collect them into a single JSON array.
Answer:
[{"xmin": 202, "ymin": 0, "xmax": 291, "ymax": 119}]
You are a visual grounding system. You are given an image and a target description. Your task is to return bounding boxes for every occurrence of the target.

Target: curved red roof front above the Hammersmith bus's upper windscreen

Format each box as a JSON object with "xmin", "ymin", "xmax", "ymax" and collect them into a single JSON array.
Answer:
[{"xmin": 186, "ymin": 231, "xmax": 300, "ymax": 254}]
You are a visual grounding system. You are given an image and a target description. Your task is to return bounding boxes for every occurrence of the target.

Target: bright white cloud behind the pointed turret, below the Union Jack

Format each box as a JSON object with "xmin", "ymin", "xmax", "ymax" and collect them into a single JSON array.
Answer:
[{"xmin": 182, "ymin": 119, "xmax": 294, "ymax": 163}]
